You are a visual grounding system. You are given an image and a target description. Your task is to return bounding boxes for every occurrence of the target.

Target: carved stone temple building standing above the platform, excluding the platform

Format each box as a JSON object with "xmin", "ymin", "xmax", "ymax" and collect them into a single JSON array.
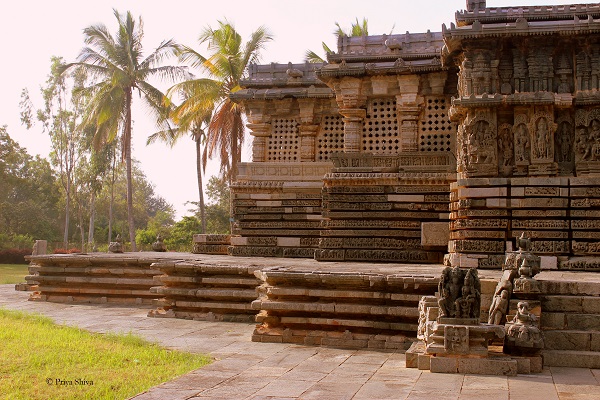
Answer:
[{"xmin": 221, "ymin": 0, "xmax": 600, "ymax": 271}]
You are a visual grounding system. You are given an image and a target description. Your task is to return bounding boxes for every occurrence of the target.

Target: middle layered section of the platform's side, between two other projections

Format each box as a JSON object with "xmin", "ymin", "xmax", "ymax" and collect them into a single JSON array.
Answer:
[{"xmin": 148, "ymin": 261, "xmax": 259, "ymax": 321}]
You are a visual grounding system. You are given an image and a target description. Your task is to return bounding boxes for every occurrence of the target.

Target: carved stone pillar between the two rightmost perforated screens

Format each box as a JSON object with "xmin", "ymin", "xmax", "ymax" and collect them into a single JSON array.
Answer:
[{"xmin": 396, "ymin": 75, "xmax": 421, "ymax": 152}]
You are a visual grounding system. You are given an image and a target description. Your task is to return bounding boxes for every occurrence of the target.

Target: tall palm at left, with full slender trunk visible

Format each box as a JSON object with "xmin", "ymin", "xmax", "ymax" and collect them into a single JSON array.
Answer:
[{"xmin": 64, "ymin": 10, "xmax": 186, "ymax": 251}]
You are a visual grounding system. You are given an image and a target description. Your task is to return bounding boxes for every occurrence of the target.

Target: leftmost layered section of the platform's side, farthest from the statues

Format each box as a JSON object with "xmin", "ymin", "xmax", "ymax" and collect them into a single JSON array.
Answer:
[{"xmin": 26, "ymin": 254, "xmax": 160, "ymax": 304}]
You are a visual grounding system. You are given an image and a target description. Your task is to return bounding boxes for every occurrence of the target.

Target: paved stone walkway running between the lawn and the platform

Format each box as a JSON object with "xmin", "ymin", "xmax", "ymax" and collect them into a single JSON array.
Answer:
[{"xmin": 0, "ymin": 285, "xmax": 600, "ymax": 400}]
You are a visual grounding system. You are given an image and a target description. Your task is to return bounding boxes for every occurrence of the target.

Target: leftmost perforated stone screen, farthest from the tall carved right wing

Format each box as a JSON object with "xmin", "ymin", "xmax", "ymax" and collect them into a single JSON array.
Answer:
[{"xmin": 267, "ymin": 118, "xmax": 300, "ymax": 162}]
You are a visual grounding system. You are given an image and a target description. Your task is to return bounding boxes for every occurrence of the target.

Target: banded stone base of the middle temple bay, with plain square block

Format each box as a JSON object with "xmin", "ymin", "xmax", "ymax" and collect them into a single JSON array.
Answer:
[{"xmin": 315, "ymin": 154, "xmax": 453, "ymax": 263}]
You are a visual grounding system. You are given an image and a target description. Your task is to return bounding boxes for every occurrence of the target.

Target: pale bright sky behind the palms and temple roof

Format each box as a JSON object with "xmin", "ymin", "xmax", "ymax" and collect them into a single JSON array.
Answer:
[{"xmin": 0, "ymin": 0, "xmax": 590, "ymax": 218}]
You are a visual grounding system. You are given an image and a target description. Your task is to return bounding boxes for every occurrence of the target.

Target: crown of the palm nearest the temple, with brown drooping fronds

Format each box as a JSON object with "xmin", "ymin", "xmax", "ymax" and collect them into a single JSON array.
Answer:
[{"xmin": 167, "ymin": 21, "xmax": 272, "ymax": 181}]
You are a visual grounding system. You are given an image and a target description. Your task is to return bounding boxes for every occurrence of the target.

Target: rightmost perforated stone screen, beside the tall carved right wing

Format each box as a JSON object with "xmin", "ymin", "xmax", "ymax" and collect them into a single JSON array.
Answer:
[{"xmin": 419, "ymin": 98, "xmax": 456, "ymax": 152}]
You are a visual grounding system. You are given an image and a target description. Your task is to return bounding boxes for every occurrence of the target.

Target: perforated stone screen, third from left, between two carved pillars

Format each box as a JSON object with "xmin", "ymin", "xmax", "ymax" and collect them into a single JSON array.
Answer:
[{"xmin": 362, "ymin": 98, "xmax": 400, "ymax": 154}]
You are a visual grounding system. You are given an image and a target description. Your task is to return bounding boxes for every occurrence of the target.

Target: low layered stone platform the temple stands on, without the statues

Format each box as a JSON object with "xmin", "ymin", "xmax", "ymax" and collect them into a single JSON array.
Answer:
[{"xmin": 17, "ymin": 252, "xmax": 600, "ymax": 368}]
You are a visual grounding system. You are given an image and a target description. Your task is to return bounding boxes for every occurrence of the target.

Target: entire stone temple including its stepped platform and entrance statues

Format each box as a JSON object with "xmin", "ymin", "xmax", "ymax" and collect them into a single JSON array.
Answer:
[{"xmin": 20, "ymin": 0, "xmax": 600, "ymax": 375}]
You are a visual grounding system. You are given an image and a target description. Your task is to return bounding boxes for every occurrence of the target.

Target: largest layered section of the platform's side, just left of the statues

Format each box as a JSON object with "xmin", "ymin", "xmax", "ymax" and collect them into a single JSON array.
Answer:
[{"xmin": 252, "ymin": 267, "xmax": 437, "ymax": 350}]
